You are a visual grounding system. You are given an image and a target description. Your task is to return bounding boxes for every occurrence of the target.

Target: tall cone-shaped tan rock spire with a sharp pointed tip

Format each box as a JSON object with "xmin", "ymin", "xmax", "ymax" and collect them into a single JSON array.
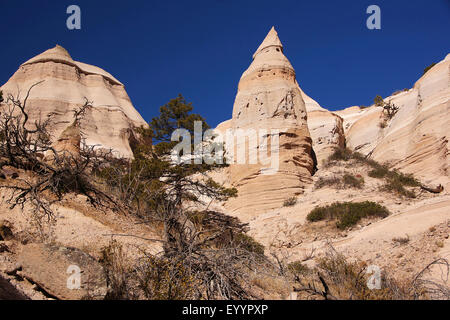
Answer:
[{"xmin": 218, "ymin": 28, "xmax": 316, "ymax": 215}]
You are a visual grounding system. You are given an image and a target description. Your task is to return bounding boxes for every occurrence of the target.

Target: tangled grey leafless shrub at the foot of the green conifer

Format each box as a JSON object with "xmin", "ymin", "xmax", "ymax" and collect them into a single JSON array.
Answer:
[{"xmin": 142, "ymin": 204, "xmax": 265, "ymax": 300}]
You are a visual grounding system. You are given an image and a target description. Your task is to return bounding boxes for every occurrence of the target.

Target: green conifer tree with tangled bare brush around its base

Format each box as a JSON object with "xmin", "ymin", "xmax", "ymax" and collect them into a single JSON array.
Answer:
[{"xmin": 100, "ymin": 95, "xmax": 265, "ymax": 299}]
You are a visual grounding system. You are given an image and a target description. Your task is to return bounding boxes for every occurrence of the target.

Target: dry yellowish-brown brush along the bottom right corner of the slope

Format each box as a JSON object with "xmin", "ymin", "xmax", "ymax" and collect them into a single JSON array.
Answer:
[{"xmin": 294, "ymin": 245, "xmax": 450, "ymax": 300}]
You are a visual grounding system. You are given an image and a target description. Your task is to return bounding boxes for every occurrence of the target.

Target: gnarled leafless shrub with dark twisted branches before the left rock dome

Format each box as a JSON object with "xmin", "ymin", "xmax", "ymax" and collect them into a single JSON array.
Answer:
[{"xmin": 0, "ymin": 82, "xmax": 116, "ymax": 236}]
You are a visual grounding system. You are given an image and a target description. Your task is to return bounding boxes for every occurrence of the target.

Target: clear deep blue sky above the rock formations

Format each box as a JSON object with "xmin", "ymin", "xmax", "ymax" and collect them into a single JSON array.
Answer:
[{"xmin": 0, "ymin": 0, "xmax": 450, "ymax": 125}]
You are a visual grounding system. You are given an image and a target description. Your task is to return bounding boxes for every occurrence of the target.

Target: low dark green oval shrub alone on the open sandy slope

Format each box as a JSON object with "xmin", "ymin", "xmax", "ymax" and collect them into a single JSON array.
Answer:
[{"xmin": 306, "ymin": 201, "xmax": 390, "ymax": 229}]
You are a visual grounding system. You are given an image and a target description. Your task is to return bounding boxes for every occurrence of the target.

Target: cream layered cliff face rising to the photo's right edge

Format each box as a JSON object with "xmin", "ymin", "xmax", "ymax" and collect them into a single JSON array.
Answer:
[{"xmin": 336, "ymin": 55, "xmax": 450, "ymax": 189}]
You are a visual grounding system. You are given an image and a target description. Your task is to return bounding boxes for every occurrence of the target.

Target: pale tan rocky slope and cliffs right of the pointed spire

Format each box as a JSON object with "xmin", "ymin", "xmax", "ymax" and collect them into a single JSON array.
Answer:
[{"xmin": 218, "ymin": 30, "xmax": 450, "ymax": 292}]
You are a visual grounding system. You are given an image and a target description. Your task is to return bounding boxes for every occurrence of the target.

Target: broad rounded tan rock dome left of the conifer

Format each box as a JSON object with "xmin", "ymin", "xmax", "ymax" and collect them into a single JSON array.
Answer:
[{"xmin": 0, "ymin": 46, "xmax": 146, "ymax": 157}]
